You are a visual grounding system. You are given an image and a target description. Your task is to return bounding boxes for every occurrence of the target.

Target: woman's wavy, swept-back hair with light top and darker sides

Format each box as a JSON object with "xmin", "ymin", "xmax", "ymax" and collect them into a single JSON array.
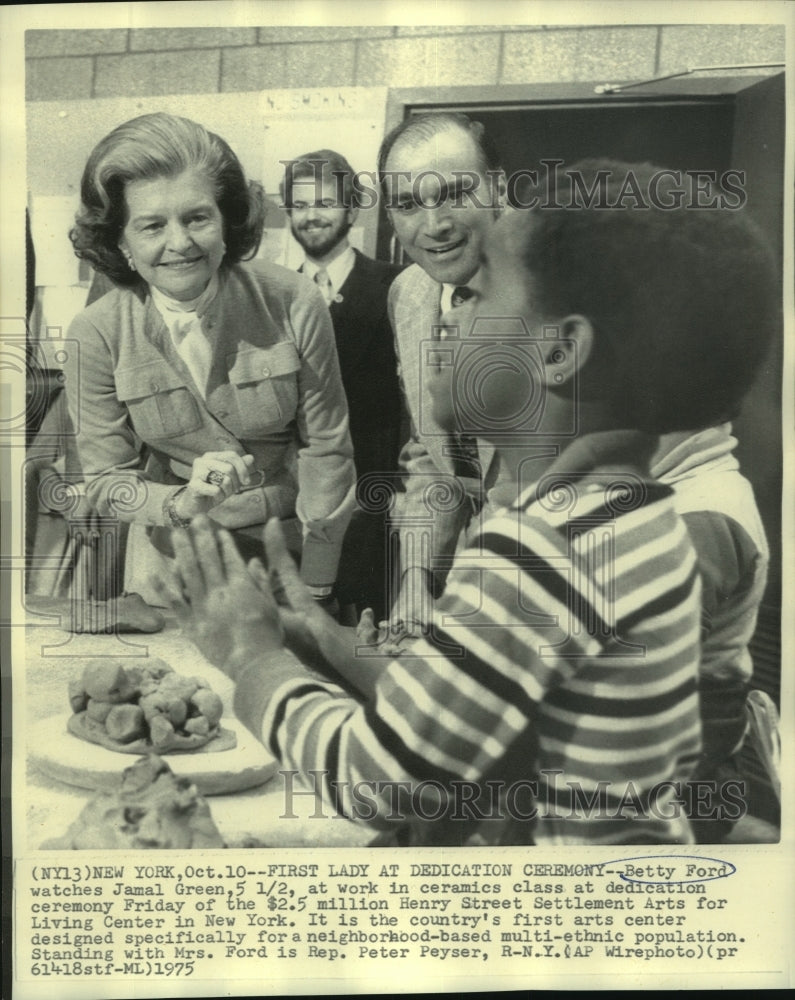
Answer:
[{"xmin": 69, "ymin": 112, "xmax": 265, "ymax": 285}]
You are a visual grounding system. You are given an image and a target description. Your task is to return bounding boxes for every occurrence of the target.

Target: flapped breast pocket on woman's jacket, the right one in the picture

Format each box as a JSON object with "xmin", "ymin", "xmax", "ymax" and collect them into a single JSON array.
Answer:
[{"xmin": 227, "ymin": 341, "xmax": 301, "ymax": 435}]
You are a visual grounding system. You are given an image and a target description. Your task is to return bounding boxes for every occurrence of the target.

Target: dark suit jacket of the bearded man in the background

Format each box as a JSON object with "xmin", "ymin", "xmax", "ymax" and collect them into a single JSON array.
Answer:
[{"xmin": 304, "ymin": 250, "xmax": 403, "ymax": 479}]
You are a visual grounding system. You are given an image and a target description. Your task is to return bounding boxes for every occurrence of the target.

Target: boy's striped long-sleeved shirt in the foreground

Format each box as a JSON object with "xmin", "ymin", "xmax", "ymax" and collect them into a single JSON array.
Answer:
[{"xmin": 263, "ymin": 446, "xmax": 700, "ymax": 843}]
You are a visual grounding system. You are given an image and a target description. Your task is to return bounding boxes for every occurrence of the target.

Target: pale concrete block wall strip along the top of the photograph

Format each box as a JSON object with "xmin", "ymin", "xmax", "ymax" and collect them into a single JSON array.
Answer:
[{"xmin": 25, "ymin": 24, "xmax": 784, "ymax": 101}]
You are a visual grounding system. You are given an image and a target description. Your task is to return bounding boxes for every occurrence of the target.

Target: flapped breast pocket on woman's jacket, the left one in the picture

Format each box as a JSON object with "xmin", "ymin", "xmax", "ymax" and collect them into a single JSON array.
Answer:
[{"xmin": 115, "ymin": 361, "xmax": 202, "ymax": 441}]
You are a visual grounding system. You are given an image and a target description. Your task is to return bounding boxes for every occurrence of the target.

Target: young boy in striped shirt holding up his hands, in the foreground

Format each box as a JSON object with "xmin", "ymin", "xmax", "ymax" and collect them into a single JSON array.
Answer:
[{"xmin": 168, "ymin": 161, "xmax": 776, "ymax": 844}]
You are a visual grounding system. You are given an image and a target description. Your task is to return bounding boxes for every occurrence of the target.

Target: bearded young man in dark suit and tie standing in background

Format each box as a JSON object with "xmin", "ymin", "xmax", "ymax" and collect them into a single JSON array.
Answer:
[{"xmin": 281, "ymin": 149, "xmax": 403, "ymax": 618}]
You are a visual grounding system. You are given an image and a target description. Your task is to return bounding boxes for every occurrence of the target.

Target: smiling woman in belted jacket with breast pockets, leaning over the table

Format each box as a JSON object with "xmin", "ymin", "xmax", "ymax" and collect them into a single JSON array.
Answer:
[{"xmin": 67, "ymin": 113, "xmax": 355, "ymax": 600}]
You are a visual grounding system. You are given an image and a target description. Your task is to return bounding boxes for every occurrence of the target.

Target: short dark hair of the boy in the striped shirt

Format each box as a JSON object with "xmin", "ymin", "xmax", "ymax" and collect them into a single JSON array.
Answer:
[{"xmin": 524, "ymin": 160, "xmax": 781, "ymax": 434}]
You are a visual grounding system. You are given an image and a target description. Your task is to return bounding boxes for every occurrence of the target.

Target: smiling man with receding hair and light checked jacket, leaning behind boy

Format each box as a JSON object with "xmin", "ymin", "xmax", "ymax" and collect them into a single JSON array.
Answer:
[{"xmin": 378, "ymin": 113, "xmax": 506, "ymax": 633}]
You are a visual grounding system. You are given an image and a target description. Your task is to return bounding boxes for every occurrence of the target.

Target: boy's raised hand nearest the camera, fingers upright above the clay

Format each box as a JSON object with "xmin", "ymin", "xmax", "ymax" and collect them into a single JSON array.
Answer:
[{"xmin": 161, "ymin": 515, "xmax": 284, "ymax": 680}]
